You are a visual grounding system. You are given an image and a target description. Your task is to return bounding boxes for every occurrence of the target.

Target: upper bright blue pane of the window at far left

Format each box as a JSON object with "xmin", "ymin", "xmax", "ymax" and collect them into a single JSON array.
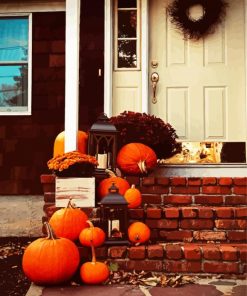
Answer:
[{"xmin": 0, "ymin": 17, "xmax": 28, "ymax": 62}]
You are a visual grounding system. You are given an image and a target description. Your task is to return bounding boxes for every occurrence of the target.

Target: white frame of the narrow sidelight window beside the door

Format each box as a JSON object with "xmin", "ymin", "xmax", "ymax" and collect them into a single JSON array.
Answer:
[{"xmin": 113, "ymin": 0, "xmax": 141, "ymax": 71}]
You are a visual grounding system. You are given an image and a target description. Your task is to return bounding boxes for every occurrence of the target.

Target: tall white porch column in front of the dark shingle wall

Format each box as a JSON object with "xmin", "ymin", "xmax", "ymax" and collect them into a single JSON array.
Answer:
[{"xmin": 64, "ymin": 0, "xmax": 81, "ymax": 152}]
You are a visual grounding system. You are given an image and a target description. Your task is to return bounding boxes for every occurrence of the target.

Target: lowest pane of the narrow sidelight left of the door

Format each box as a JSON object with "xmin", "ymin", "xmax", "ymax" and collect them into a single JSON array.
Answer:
[{"xmin": 118, "ymin": 40, "xmax": 137, "ymax": 68}]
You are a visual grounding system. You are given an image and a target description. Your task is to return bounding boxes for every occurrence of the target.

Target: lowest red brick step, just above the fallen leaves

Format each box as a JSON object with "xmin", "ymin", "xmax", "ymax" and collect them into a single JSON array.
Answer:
[{"xmin": 76, "ymin": 243, "xmax": 247, "ymax": 275}]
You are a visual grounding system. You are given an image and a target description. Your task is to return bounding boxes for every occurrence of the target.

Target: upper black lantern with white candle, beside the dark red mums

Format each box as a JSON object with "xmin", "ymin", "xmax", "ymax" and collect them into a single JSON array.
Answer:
[{"xmin": 88, "ymin": 113, "xmax": 118, "ymax": 174}]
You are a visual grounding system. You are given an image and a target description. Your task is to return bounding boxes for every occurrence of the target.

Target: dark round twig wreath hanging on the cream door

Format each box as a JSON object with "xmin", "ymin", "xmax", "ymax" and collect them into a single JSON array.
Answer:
[{"xmin": 168, "ymin": 0, "xmax": 228, "ymax": 40}]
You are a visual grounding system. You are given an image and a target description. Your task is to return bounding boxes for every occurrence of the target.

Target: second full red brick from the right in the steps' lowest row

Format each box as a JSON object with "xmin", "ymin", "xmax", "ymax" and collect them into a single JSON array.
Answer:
[{"xmin": 164, "ymin": 260, "xmax": 202, "ymax": 273}]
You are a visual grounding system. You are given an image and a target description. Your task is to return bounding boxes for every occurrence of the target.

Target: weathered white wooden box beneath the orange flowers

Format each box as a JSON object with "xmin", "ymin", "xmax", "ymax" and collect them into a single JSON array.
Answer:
[{"xmin": 56, "ymin": 177, "xmax": 95, "ymax": 208}]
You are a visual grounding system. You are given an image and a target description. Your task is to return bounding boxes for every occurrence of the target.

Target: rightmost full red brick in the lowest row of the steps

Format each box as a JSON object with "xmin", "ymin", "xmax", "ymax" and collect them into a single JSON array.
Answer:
[{"xmin": 203, "ymin": 262, "xmax": 239, "ymax": 274}]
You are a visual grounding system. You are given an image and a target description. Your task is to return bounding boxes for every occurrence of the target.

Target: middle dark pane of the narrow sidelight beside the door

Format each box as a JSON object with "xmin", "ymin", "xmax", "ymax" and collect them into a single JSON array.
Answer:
[{"xmin": 118, "ymin": 10, "xmax": 137, "ymax": 38}]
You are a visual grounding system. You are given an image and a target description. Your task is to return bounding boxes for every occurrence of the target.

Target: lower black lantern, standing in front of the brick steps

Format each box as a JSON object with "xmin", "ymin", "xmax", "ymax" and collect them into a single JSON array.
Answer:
[{"xmin": 100, "ymin": 183, "xmax": 129, "ymax": 245}]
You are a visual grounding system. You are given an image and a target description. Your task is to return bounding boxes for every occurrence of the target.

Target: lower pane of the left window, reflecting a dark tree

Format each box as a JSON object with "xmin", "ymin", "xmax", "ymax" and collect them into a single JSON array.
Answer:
[{"xmin": 0, "ymin": 65, "xmax": 28, "ymax": 108}]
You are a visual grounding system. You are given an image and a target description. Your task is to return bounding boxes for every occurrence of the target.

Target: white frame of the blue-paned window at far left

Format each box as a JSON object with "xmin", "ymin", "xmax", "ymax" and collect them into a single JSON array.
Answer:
[{"xmin": 0, "ymin": 13, "xmax": 32, "ymax": 116}]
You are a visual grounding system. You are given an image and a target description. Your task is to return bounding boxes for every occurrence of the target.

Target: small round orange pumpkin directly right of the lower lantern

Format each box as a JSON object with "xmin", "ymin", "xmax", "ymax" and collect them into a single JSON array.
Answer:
[{"xmin": 128, "ymin": 222, "xmax": 150, "ymax": 244}]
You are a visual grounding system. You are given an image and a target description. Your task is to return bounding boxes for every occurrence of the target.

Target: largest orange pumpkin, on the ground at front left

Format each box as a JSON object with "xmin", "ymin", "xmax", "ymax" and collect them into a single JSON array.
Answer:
[{"xmin": 22, "ymin": 222, "xmax": 80, "ymax": 285}]
